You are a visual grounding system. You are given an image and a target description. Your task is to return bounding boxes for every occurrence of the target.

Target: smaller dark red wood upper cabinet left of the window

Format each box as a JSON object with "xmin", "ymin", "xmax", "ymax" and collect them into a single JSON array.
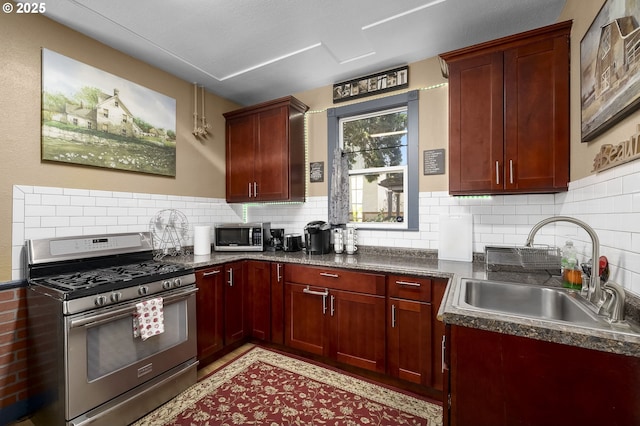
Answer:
[{"xmin": 224, "ymin": 96, "xmax": 308, "ymax": 203}]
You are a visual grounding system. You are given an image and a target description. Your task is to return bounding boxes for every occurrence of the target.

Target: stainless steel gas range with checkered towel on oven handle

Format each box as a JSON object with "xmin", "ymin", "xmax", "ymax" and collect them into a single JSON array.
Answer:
[{"xmin": 26, "ymin": 232, "xmax": 198, "ymax": 425}]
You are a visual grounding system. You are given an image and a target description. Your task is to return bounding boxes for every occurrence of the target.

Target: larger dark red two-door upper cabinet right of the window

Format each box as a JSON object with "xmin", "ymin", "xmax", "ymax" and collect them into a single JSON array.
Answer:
[{"xmin": 440, "ymin": 21, "xmax": 571, "ymax": 195}]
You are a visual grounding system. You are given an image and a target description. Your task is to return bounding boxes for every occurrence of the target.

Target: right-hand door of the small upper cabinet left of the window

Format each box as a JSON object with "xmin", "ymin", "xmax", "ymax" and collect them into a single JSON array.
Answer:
[{"xmin": 254, "ymin": 106, "xmax": 289, "ymax": 201}]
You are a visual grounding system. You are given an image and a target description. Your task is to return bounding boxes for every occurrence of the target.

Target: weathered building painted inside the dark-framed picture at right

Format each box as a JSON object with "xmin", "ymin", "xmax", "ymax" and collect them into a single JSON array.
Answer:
[{"xmin": 595, "ymin": 16, "xmax": 640, "ymax": 98}]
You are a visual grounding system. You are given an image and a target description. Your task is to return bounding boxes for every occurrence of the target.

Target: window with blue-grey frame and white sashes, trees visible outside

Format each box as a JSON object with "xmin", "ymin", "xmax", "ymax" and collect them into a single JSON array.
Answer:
[{"xmin": 327, "ymin": 91, "xmax": 418, "ymax": 230}]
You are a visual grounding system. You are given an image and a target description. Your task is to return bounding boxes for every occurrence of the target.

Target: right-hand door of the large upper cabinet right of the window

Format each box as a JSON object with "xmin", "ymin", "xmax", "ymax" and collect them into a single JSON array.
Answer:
[{"xmin": 504, "ymin": 36, "xmax": 570, "ymax": 191}]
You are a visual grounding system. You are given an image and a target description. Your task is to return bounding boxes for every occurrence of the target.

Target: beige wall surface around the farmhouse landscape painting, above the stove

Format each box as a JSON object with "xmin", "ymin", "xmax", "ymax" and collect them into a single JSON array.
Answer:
[{"xmin": 0, "ymin": 13, "xmax": 237, "ymax": 281}]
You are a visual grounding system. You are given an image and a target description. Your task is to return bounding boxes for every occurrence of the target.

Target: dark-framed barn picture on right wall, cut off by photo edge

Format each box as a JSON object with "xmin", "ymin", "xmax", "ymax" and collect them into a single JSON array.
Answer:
[{"xmin": 580, "ymin": 0, "xmax": 640, "ymax": 142}]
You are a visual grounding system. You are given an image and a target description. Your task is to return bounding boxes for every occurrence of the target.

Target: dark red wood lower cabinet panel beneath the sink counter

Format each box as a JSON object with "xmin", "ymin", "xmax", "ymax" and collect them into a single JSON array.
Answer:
[{"xmin": 449, "ymin": 325, "xmax": 640, "ymax": 426}]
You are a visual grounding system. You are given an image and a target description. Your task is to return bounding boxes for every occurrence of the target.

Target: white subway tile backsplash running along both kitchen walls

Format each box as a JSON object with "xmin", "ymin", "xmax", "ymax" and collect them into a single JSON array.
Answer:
[{"xmin": 12, "ymin": 161, "xmax": 640, "ymax": 293}]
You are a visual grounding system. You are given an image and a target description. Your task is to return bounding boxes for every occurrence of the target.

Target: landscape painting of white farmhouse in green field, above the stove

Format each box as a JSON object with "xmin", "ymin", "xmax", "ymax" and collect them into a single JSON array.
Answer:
[{"xmin": 42, "ymin": 49, "xmax": 176, "ymax": 176}]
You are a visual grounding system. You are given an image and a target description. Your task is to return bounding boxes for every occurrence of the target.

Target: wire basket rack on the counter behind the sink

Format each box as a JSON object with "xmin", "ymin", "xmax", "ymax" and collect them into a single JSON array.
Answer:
[{"xmin": 485, "ymin": 246, "xmax": 562, "ymax": 271}]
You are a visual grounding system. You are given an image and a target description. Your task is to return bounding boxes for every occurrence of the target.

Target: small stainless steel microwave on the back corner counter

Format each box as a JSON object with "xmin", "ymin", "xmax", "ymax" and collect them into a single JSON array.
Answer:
[{"xmin": 214, "ymin": 222, "xmax": 271, "ymax": 251}]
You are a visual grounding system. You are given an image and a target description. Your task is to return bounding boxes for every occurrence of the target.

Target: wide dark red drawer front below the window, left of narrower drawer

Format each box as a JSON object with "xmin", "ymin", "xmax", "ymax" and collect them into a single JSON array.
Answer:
[{"xmin": 284, "ymin": 265, "xmax": 385, "ymax": 295}]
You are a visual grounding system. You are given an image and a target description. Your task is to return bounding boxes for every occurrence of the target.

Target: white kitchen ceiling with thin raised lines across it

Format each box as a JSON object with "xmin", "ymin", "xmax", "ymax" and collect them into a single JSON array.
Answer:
[{"xmin": 20, "ymin": 0, "xmax": 566, "ymax": 105}]
